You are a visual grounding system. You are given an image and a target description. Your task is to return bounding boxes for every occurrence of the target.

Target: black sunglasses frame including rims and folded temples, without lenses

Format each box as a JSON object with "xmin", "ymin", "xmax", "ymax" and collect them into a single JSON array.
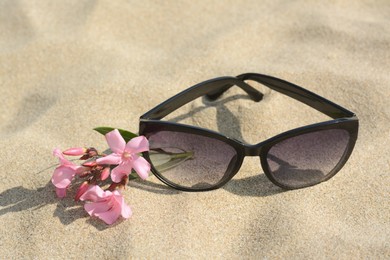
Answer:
[{"xmin": 139, "ymin": 73, "xmax": 359, "ymax": 191}]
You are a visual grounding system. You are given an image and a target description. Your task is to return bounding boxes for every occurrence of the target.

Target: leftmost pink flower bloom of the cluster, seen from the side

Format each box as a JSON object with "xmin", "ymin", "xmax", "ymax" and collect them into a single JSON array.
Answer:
[{"xmin": 51, "ymin": 149, "xmax": 86, "ymax": 198}]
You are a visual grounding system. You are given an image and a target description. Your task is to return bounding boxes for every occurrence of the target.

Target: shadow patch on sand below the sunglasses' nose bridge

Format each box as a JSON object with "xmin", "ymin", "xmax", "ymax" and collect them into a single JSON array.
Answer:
[{"xmin": 222, "ymin": 174, "xmax": 286, "ymax": 197}]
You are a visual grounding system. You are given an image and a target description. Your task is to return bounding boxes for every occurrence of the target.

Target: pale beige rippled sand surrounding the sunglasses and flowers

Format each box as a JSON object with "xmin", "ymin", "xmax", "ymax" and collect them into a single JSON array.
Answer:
[{"xmin": 0, "ymin": 0, "xmax": 390, "ymax": 259}]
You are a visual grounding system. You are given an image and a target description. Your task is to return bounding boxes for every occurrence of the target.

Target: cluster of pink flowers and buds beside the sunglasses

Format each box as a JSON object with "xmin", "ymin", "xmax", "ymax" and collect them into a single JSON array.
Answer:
[{"xmin": 51, "ymin": 129, "xmax": 150, "ymax": 225}]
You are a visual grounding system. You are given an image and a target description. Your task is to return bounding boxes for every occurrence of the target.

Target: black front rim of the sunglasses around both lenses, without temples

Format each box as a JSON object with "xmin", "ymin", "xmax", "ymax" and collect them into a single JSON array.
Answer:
[{"xmin": 139, "ymin": 116, "xmax": 359, "ymax": 191}]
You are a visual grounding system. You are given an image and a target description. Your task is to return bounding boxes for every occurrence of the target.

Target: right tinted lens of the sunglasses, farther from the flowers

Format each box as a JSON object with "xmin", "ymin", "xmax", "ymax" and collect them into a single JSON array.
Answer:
[{"xmin": 267, "ymin": 129, "xmax": 349, "ymax": 188}]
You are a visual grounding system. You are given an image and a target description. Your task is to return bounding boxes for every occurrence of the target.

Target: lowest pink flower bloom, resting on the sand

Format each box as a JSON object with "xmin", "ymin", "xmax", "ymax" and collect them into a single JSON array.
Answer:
[{"xmin": 80, "ymin": 185, "xmax": 132, "ymax": 225}]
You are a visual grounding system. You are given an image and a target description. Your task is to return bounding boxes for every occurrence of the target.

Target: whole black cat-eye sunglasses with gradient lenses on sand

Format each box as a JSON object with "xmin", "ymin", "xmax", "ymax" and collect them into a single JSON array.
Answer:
[{"xmin": 139, "ymin": 73, "xmax": 359, "ymax": 191}]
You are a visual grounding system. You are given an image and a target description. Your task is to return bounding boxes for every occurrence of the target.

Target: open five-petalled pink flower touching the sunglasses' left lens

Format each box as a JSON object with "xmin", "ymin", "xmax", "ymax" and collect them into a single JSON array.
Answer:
[{"xmin": 96, "ymin": 129, "xmax": 150, "ymax": 182}]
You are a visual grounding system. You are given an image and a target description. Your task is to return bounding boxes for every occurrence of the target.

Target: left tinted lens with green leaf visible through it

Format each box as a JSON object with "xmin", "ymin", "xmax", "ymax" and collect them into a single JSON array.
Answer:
[{"xmin": 147, "ymin": 131, "xmax": 237, "ymax": 189}]
